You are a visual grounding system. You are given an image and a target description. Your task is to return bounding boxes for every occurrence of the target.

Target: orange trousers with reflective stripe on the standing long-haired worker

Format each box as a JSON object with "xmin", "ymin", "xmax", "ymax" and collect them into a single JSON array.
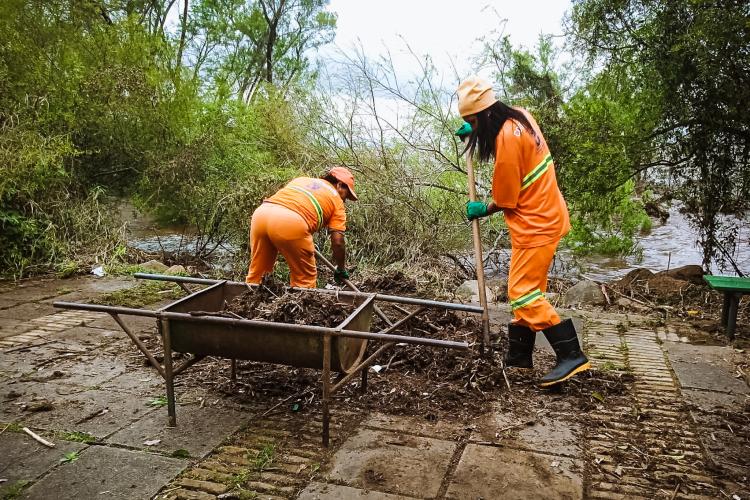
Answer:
[{"xmin": 508, "ymin": 242, "xmax": 560, "ymax": 331}]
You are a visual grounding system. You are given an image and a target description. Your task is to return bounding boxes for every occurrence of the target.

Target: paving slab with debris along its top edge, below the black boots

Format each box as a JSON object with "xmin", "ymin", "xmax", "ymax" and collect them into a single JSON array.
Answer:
[{"xmin": 470, "ymin": 408, "xmax": 583, "ymax": 457}]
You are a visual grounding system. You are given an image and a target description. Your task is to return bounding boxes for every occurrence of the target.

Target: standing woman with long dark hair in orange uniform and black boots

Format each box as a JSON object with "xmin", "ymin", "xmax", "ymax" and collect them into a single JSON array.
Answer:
[{"xmin": 458, "ymin": 76, "xmax": 591, "ymax": 387}]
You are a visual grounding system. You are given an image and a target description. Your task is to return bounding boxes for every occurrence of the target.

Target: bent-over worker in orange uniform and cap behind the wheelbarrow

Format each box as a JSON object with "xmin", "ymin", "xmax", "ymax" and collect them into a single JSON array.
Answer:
[{"xmin": 245, "ymin": 167, "xmax": 357, "ymax": 288}]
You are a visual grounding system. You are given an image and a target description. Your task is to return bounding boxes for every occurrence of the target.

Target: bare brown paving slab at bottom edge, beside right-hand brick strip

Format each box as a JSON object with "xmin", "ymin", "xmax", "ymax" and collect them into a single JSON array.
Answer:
[{"xmin": 446, "ymin": 444, "xmax": 583, "ymax": 500}]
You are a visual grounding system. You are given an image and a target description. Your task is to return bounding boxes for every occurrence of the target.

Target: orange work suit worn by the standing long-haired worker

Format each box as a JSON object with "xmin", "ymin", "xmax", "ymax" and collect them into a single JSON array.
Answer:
[{"xmin": 492, "ymin": 110, "xmax": 570, "ymax": 331}]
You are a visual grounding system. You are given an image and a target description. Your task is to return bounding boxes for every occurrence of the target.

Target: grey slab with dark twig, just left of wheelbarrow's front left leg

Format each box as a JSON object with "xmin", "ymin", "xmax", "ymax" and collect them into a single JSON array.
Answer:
[{"xmin": 22, "ymin": 386, "xmax": 159, "ymax": 438}]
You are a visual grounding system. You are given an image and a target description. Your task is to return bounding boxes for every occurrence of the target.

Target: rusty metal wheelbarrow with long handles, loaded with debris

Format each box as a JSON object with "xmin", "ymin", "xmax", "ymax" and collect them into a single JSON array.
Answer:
[{"xmin": 54, "ymin": 273, "xmax": 482, "ymax": 447}]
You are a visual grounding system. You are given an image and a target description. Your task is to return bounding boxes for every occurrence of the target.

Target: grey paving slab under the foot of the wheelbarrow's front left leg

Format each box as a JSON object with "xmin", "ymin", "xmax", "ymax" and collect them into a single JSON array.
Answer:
[{"xmin": 106, "ymin": 404, "xmax": 250, "ymax": 457}]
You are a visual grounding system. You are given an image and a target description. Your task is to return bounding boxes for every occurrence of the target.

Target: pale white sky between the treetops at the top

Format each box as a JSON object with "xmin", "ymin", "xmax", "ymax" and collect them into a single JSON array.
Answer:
[{"xmin": 319, "ymin": 0, "xmax": 571, "ymax": 80}]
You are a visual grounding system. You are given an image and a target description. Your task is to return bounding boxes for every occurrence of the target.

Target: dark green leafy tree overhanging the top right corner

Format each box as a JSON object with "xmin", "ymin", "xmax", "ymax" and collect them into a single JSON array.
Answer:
[{"xmin": 568, "ymin": 0, "xmax": 750, "ymax": 272}]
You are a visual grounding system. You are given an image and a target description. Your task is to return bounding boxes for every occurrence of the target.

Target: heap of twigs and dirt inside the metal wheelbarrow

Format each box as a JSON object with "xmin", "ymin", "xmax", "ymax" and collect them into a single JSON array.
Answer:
[{"xmin": 222, "ymin": 278, "xmax": 356, "ymax": 328}]
